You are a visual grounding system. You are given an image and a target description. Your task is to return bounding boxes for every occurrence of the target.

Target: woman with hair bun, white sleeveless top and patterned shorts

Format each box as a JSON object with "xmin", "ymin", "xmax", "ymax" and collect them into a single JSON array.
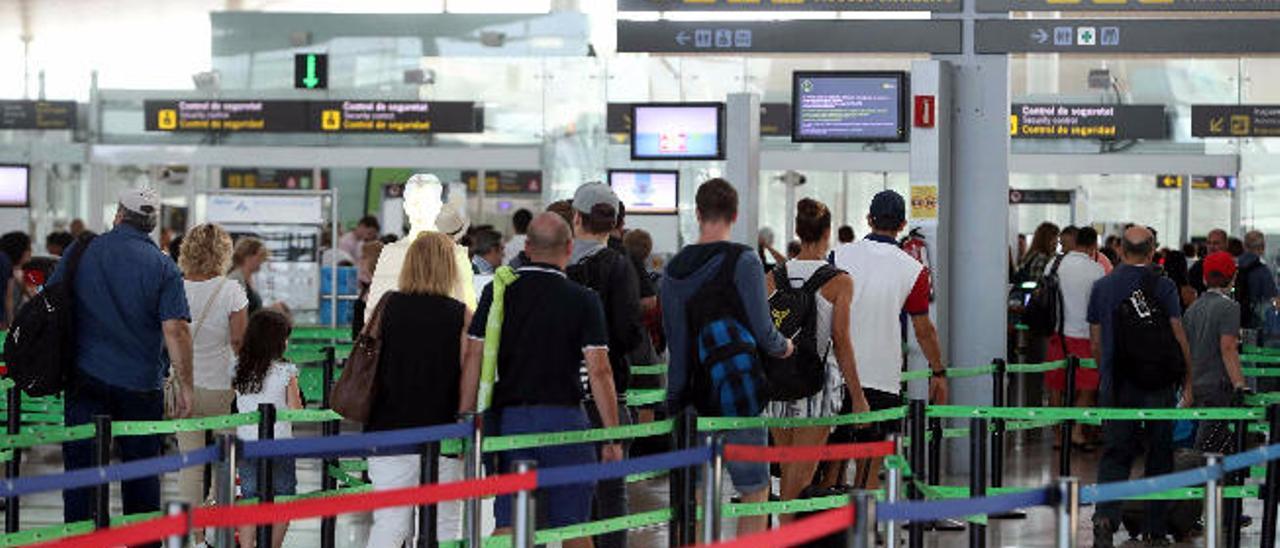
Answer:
[{"xmin": 764, "ymin": 198, "xmax": 868, "ymax": 522}]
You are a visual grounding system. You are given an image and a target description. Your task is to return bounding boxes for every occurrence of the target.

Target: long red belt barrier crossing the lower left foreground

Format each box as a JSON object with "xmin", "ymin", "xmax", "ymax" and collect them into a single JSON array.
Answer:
[{"xmin": 32, "ymin": 471, "xmax": 538, "ymax": 548}]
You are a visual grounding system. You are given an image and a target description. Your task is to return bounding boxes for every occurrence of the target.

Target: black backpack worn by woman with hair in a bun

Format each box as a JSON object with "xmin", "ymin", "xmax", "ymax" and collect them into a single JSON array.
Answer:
[{"xmin": 764, "ymin": 264, "xmax": 840, "ymax": 402}]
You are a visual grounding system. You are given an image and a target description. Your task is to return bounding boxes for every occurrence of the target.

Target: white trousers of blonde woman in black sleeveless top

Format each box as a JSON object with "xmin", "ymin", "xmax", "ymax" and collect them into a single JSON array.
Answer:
[{"xmin": 366, "ymin": 455, "xmax": 463, "ymax": 548}]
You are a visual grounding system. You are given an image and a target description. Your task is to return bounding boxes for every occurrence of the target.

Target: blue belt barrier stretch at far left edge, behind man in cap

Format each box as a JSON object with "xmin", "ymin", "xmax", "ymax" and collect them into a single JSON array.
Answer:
[{"xmin": 0, "ymin": 446, "xmax": 223, "ymax": 497}]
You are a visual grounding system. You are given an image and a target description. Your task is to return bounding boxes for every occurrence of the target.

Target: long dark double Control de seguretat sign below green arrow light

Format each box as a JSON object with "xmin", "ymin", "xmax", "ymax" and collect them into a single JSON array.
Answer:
[{"xmin": 143, "ymin": 100, "xmax": 484, "ymax": 133}]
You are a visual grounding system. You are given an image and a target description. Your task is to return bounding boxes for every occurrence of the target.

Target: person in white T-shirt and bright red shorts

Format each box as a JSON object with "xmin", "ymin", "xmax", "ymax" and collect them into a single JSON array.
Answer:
[{"xmin": 1044, "ymin": 227, "xmax": 1106, "ymax": 448}]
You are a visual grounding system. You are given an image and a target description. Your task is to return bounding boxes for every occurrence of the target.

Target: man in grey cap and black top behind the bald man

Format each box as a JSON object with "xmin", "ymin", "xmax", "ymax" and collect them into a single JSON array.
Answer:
[{"xmin": 566, "ymin": 183, "xmax": 644, "ymax": 547}]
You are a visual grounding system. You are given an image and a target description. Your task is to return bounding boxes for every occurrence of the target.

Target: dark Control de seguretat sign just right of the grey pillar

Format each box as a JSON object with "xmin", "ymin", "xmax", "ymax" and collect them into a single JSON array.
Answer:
[{"xmin": 1009, "ymin": 104, "xmax": 1169, "ymax": 140}]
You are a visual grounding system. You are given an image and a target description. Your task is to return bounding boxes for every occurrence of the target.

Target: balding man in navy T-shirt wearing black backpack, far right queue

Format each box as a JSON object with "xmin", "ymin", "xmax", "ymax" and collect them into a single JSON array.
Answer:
[{"xmin": 1088, "ymin": 227, "xmax": 1194, "ymax": 548}]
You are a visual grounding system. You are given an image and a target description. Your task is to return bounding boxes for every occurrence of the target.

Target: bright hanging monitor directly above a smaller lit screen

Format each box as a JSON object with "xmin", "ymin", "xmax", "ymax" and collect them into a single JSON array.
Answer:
[{"xmin": 631, "ymin": 102, "xmax": 724, "ymax": 160}]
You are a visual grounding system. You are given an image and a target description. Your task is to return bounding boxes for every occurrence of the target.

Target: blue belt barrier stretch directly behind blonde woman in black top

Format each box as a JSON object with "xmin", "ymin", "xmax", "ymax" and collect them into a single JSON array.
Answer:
[{"xmin": 241, "ymin": 423, "xmax": 471, "ymax": 458}]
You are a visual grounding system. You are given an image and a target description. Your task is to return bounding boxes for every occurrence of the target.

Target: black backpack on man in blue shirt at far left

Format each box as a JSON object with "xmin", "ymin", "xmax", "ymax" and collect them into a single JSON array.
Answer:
[{"xmin": 4, "ymin": 234, "xmax": 93, "ymax": 397}]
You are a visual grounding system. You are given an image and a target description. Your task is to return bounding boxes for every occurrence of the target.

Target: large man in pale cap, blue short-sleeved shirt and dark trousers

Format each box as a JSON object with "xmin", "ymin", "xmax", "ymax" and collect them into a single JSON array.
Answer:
[{"xmin": 52, "ymin": 188, "xmax": 193, "ymax": 530}]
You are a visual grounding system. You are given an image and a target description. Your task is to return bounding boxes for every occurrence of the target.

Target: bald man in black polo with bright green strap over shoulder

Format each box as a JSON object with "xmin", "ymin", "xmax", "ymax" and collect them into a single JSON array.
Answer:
[{"xmin": 458, "ymin": 213, "xmax": 622, "ymax": 548}]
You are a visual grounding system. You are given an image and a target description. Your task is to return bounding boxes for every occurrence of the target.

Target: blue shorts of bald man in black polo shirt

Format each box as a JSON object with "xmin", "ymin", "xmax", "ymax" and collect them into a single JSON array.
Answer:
[{"xmin": 490, "ymin": 406, "xmax": 596, "ymax": 528}]
